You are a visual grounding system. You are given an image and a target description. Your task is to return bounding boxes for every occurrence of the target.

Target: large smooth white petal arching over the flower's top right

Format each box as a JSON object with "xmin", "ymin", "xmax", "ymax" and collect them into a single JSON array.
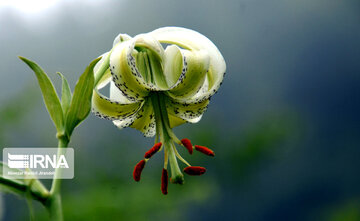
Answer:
[{"xmin": 150, "ymin": 27, "xmax": 226, "ymax": 102}]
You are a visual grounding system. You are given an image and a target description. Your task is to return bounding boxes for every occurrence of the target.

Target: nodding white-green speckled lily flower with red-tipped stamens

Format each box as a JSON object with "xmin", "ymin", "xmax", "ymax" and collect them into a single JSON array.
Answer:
[{"xmin": 92, "ymin": 27, "xmax": 226, "ymax": 194}]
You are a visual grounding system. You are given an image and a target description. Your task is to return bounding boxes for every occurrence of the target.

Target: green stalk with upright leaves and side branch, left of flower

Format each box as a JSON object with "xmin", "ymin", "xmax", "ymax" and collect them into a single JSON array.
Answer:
[{"xmin": 0, "ymin": 57, "xmax": 100, "ymax": 221}]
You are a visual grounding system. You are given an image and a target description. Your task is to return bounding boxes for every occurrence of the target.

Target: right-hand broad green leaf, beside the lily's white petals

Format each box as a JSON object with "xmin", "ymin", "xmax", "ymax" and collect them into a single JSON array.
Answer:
[{"xmin": 66, "ymin": 58, "xmax": 101, "ymax": 137}]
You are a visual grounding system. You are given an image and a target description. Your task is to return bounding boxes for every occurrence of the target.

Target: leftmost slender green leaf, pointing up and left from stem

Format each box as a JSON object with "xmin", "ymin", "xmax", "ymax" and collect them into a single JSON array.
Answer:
[{"xmin": 19, "ymin": 57, "xmax": 64, "ymax": 133}]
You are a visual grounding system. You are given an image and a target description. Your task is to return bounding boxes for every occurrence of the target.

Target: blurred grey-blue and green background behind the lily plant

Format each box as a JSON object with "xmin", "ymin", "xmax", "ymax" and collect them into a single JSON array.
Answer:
[{"xmin": 0, "ymin": 0, "xmax": 360, "ymax": 221}]
